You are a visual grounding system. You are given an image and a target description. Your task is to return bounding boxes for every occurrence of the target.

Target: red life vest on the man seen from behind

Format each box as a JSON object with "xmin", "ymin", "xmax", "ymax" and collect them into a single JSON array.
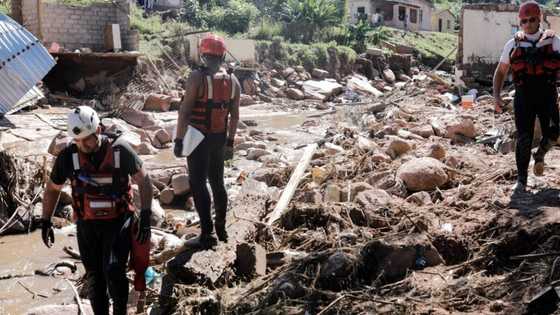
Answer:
[{"xmin": 190, "ymin": 71, "xmax": 235, "ymax": 134}]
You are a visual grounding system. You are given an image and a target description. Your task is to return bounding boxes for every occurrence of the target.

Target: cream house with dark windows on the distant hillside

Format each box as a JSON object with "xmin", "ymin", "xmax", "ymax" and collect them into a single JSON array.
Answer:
[{"xmin": 348, "ymin": 0, "xmax": 435, "ymax": 31}]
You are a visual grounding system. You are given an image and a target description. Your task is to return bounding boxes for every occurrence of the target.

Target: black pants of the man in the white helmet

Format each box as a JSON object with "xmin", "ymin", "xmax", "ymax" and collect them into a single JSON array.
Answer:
[{"xmin": 77, "ymin": 215, "xmax": 133, "ymax": 315}]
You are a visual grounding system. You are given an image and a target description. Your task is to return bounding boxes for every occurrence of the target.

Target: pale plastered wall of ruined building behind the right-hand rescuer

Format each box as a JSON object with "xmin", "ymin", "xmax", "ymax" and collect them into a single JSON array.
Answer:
[{"xmin": 456, "ymin": 4, "xmax": 560, "ymax": 86}]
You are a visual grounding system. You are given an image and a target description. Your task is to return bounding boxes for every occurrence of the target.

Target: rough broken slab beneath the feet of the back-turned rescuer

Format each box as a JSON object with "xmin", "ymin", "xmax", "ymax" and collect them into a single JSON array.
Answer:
[{"xmin": 166, "ymin": 179, "xmax": 269, "ymax": 286}]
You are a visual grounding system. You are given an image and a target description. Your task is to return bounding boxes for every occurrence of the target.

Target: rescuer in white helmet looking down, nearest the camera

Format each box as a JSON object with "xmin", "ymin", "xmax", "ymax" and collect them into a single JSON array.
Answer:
[{"xmin": 42, "ymin": 106, "xmax": 153, "ymax": 315}]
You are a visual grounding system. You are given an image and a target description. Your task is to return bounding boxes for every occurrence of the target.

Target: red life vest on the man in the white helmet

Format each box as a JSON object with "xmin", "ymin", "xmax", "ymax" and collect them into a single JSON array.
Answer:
[{"xmin": 71, "ymin": 139, "xmax": 134, "ymax": 220}]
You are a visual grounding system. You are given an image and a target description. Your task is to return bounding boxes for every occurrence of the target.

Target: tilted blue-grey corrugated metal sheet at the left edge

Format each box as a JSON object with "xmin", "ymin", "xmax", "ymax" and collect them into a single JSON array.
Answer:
[{"xmin": 0, "ymin": 14, "xmax": 55, "ymax": 114}]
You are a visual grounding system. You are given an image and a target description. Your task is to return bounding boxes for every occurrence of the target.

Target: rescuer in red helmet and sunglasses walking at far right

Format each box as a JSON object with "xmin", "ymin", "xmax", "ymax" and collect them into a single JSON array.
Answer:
[{"xmin": 494, "ymin": 1, "xmax": 560, "ymax": 192}]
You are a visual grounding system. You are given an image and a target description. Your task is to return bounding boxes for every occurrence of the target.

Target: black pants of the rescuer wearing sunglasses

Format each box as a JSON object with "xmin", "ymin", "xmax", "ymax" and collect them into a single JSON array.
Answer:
[{"xmin": 513, "ymin": 82, "xmax": 559, "ymax": 184}]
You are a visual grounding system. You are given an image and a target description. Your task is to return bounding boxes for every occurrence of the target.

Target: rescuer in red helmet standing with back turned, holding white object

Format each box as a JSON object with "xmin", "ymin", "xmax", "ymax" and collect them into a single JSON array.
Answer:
[{"xmin": 174, "ymin": 34, "xmax": 241, "ymax": 248}]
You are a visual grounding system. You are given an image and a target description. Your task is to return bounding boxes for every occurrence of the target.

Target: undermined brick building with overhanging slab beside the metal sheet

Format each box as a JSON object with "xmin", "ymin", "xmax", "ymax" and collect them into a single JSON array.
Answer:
[{"xmin": 12, "ymin": 0, "xmax": 140, "ymax": 98}]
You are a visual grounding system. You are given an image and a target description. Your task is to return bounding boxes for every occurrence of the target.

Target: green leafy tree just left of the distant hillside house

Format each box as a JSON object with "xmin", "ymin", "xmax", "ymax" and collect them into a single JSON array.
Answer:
[{"xmin": 282, "ymin": 0, "xmax": 340, "ymax": 43}]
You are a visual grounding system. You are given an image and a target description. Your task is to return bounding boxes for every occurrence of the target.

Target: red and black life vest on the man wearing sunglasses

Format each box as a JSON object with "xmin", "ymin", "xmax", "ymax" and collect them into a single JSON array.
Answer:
[{"xmin": 510, "ymin": 35, "xmax": 560, "ymax": 86}]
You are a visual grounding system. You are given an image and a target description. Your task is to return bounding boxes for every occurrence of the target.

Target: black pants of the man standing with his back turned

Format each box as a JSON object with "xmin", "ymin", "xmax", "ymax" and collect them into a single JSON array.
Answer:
[{"xmin": 187, "ymin": 134, "xmax": 227, "ymax": 235}]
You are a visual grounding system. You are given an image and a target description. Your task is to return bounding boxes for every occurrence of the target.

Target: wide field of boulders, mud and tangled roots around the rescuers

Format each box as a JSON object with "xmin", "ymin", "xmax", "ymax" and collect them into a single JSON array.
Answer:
[{"xmin": 0, "ymin": 51, "xmax": 560, "ymax": 314}]
